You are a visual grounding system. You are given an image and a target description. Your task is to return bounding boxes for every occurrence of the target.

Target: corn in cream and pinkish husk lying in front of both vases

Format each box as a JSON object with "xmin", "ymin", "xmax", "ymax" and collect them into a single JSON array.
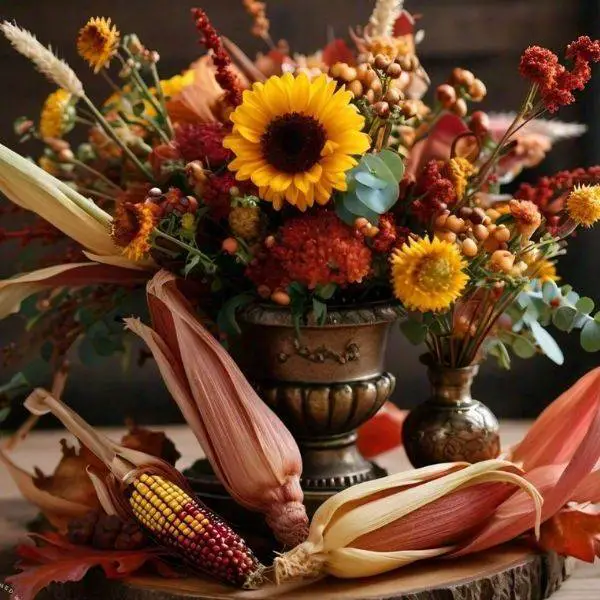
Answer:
[{"xmin": 275, "ymin": 460, "xmax": 542, "ymax": 582}]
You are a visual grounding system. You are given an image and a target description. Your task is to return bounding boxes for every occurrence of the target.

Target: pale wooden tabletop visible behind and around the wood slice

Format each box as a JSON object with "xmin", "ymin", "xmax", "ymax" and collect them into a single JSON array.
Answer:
[{"xmin": 0, "ymin": 421, "xmax": 600, "ymax": 600}]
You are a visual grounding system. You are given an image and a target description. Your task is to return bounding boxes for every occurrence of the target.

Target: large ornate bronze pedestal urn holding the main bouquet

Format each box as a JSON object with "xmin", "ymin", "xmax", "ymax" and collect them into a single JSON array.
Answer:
[{"xmin": 235, "ymin": 304, "xmax": 397, "ymax": 509}]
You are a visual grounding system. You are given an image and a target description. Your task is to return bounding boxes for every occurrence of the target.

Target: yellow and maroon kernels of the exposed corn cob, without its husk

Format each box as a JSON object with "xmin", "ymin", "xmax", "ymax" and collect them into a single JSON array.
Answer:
[{"xmin": 129, "ymin": 474, "xmax": 261, "ymax": 587}]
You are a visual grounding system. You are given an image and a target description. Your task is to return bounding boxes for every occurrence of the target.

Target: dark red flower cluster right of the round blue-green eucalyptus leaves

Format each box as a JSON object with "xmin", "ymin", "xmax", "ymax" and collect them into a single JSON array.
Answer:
[{"xmin": 412, "ymin": 160, "xmax": 456, "ymax": 223}]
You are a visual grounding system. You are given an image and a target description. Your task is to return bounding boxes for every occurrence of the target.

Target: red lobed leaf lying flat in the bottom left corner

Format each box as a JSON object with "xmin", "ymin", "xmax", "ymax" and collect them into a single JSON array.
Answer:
[{"xmin": 6, "ymin": 534, "xmax": 174, "ymax": 600}]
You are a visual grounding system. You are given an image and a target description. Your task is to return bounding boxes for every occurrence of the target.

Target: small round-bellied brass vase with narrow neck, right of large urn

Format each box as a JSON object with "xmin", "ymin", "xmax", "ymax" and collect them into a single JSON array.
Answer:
[{"xmin": 402, "ymin": 361, "xmax": 500, "ymax": 468}]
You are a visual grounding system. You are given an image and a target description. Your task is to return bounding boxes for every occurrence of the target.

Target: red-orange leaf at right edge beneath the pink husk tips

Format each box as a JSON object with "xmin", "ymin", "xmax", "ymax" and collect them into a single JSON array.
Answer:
[{"xmin": 539, "ymin": 504, "xmax": 600, "ymax": 563}]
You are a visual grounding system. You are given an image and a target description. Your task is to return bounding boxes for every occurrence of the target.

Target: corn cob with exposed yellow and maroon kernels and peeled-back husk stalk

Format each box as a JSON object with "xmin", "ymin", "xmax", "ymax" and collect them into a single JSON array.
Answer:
[{"xmin": 25, "ymin": 389, "xmax": 263, "ymax": 587}]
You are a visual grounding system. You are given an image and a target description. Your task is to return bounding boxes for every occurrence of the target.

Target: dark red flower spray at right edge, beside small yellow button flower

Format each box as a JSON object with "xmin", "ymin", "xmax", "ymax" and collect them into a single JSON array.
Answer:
[{"xmin": 515, "ymin": 165, "xmax": 600, "ymax": 232}]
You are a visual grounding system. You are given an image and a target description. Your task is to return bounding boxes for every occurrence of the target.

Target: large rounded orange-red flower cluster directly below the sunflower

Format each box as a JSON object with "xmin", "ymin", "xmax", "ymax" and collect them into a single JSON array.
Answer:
[{"xmin": 247, "ymin": 211, "xmax": 372, "ymax": 290}]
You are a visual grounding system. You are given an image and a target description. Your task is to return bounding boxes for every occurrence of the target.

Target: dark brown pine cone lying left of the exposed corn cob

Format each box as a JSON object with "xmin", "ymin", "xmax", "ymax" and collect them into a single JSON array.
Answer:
[{"xmin": 67, "ymin": 511, "xmax": 148, "ymax": 550}]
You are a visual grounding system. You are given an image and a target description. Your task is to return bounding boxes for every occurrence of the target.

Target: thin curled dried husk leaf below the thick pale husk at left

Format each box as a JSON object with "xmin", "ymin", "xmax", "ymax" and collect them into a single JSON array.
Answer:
[{"xmin": 0, "ymin": 262, "xmax": 147, "ymax": 319}]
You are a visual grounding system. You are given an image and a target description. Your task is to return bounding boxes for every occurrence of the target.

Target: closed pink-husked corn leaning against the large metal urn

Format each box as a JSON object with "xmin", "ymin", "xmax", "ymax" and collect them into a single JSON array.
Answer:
[{"xmin": 127, "ymin": 271, "xmax": 308, "ymax": 546}]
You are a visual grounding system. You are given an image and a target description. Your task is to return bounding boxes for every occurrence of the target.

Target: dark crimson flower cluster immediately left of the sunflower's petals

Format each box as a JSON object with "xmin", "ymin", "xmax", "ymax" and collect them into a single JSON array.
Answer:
[{"xmin": 175, "ymin": 123, "xmax": 233, "ymax": 168}]
